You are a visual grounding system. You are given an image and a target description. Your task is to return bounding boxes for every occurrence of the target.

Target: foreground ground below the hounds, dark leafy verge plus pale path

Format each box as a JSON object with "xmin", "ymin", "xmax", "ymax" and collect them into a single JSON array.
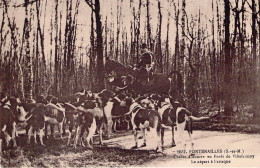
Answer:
[{"xmin": 0, "ymin": 130, "xmax": 260, "ymax": 167}]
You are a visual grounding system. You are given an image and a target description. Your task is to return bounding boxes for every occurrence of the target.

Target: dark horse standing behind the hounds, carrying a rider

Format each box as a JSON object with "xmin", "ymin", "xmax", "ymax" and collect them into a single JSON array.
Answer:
[{"xmin": 105, "ymin": 59, "xmax": 182, "ymax": 99}]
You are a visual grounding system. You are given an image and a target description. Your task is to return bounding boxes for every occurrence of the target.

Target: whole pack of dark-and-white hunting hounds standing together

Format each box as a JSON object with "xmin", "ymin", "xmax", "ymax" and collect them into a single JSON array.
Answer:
[{"xmin": 0, "ymin": 89, "xmax": 208, "ymax": 151}]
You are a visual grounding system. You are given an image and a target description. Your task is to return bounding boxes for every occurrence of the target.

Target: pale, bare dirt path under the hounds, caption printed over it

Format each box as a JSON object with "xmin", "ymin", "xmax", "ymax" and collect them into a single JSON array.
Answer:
[{"xmin": 104, "ymin": 131, "xmax": 260, "ymax": 167}]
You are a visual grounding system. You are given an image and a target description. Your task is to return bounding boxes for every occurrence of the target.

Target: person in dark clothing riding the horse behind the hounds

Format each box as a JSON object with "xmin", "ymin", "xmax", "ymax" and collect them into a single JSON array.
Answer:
[{"xmin": 136, "ymin": 43, "xmax": 155, "ymax": 81}]
